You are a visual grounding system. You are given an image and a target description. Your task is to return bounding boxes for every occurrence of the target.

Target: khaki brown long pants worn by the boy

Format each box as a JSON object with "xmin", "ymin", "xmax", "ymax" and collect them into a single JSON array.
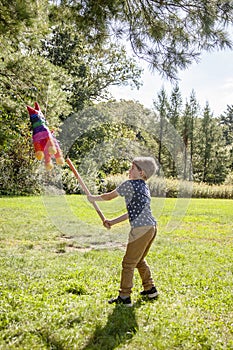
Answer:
[{"xmin": 119, "ymin": 226, "xmax": 157, "ymax": 296}]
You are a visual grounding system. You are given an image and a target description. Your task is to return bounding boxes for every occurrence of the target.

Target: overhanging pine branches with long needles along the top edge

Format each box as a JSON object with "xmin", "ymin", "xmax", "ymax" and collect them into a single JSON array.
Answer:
[{"xmin": 57, "ymin": 0, "xmax": 233, "ymax": 78}]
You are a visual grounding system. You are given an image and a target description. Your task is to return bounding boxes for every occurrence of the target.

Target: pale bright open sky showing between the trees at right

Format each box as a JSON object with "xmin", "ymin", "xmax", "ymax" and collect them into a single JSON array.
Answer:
[{"xmin": 110, "ymin": 49, "xmax": 233, "ymax": 117}]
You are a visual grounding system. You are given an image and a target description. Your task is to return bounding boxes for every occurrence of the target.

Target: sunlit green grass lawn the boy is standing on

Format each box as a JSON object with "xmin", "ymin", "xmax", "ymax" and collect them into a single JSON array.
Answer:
[{"xmin": 0, "ymin": 196, "xmax": 233, "ymax": 350}]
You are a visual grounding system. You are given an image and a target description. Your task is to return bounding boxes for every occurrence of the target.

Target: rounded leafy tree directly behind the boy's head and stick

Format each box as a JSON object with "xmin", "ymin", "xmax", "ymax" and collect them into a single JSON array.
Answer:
[{"xmin": 61, "ymin": 100, "xmax": 157, "ymax": 193}]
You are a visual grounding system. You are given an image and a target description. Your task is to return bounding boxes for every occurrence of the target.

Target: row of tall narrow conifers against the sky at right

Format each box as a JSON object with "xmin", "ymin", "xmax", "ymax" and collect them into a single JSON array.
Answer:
[{"xmin": 154, "ymin": 87, "xmax": 232, "ymax": 184}]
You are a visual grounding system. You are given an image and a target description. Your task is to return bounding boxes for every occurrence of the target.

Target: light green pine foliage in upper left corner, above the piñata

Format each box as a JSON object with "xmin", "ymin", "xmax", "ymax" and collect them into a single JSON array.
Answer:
[{"xmin": 0, "ymin": 0, "xmax": 70, "ymax": 119}]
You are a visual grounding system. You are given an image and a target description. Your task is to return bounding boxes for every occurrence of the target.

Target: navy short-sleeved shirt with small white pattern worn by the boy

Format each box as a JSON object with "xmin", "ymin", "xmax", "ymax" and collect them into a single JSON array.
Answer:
[{"xmin": 116, "ymin": 180, "xmax": 156, "ymax": 227}]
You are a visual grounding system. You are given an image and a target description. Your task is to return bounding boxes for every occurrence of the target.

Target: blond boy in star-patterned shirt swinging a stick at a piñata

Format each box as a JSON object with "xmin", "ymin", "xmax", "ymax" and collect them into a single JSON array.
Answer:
[{"xmin": 88, "ymin": 157, "xmax": 158, "ymax": 306}]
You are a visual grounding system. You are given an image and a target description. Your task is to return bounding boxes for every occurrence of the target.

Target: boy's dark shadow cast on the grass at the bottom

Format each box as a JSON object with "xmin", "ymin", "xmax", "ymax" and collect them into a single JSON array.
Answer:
[{"xmin": 80, "ymin": 301, "xmax": 141, "ymax": 350}]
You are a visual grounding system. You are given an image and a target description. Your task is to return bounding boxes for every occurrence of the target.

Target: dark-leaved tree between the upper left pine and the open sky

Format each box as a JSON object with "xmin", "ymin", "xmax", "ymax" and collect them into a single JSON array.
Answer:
[{"xmin": 40, "ymin": 23, "xmax": 141, "ymax": 112}]
